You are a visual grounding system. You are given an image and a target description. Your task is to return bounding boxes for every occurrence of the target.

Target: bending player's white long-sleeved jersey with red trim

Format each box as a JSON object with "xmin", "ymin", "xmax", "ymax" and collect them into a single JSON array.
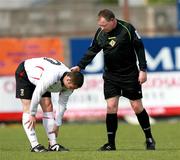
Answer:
[{"xmin": 24, "ymin": 57, "xmax": 72, "ymax": 124}]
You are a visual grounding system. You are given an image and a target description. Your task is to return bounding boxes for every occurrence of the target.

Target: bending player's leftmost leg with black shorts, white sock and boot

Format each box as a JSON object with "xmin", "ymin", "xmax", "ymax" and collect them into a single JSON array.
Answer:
[{"xmin": 15, "ymin": 62, "xmax": 46, "ymax": 152}]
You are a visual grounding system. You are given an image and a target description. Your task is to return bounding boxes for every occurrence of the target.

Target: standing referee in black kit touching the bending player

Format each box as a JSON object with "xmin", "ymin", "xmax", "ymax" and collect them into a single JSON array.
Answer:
[{"xmin": 71, "ymin": 9, "xmax": 155, "ymax": 151}]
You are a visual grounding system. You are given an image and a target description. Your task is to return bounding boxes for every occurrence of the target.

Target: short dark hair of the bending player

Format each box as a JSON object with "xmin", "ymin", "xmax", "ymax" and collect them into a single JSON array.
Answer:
[{"xmin": 67, "ymin": 71, "xmax": 84, "ymax": 88}]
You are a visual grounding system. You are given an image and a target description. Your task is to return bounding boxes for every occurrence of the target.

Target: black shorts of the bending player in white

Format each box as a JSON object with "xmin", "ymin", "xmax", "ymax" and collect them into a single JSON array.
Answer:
[{"xmin": 15, "ymin": 62, "xmax": 51, "ymax": 99}]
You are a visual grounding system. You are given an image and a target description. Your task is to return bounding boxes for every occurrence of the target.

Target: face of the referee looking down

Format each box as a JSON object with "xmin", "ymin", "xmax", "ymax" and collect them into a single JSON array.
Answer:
[{"xmin": 98, "ymin": 17, "xmax": 115, "ymax": 32}]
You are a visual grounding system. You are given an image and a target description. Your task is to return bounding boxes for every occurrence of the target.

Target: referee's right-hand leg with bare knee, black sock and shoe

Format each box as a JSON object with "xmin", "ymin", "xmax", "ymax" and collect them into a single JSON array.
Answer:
[{"xmin": 130, "ymin": 99, "xmax": 155, "ymax": 150}]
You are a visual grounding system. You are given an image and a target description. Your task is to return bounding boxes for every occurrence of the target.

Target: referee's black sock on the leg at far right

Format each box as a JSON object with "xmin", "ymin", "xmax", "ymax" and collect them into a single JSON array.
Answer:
[{"xmin": 136, "ymin": 109, "xmax": 152, "ymax": 138}]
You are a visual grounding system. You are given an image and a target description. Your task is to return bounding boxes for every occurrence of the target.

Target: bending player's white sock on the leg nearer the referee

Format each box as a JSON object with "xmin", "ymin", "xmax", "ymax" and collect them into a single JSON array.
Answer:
[{"xmin": 43, "ymin": 112, "xmax": 56, "ymax": 146}]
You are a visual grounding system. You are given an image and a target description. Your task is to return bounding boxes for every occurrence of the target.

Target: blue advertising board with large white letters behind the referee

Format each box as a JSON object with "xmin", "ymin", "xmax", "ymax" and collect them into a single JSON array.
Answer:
[{"xmin": 70, "ymin": 36, "xmax": 180, "ymax": 74}]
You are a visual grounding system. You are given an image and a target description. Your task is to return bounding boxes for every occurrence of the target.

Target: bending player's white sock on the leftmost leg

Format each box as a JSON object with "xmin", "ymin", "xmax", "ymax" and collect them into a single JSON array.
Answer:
[{"xmin": 22, "ymin": 113, "xmax": 39, "ymax": 148}]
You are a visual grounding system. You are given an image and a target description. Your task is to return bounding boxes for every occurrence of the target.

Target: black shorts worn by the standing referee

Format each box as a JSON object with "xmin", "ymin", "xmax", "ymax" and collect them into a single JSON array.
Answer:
[{"xmin": 104, "ymin": 79, "xmax": 142, "ymax": 100}]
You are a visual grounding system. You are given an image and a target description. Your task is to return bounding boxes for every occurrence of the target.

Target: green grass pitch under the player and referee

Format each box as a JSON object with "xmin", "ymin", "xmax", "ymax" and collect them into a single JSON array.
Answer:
[{"xmin": 0, "ymin": 121, "xmax": 180, "ymax": 160}]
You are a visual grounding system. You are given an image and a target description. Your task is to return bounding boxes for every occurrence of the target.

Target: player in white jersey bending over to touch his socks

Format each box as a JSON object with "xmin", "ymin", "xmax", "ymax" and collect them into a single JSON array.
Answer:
[{"xmin": 15, "ymin": 57, "xmax": 84, "ymax": 152}]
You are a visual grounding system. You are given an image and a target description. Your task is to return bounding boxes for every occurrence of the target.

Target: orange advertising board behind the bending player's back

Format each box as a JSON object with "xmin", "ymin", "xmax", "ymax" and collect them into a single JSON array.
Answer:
[{"xmin": 0, "ymin": 37, "xmax": 64, "ymax": 76}]
